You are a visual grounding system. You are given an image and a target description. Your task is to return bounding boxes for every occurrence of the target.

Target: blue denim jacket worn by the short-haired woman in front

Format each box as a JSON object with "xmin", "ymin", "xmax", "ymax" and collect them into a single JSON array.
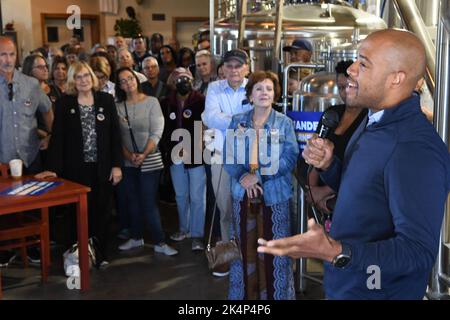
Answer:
[{"xmin": 223, "ymin": 109, "xmax": 299, "ymax": 206}]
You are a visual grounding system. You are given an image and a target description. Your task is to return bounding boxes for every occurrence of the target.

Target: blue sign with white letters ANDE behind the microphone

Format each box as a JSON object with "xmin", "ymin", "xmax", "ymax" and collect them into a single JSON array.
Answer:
[{"xmin": 287, "ymin": 111, "xmax": 322, "ymax": 155}]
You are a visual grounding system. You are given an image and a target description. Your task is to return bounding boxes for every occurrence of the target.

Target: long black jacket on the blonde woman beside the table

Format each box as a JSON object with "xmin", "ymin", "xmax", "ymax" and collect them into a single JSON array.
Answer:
[{"xmin": 46, "ymin": 92, "xmax": 123, "ymax": 182}]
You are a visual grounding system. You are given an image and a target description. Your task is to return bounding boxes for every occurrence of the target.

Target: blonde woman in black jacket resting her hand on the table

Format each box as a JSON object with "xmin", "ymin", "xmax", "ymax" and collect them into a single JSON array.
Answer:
[{"xmin": 37, "ymin": 62, "xmax": 123, "ymax": 267}]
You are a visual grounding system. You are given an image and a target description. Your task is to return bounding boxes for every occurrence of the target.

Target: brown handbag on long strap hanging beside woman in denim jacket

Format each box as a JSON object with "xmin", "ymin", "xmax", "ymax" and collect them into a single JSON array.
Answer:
[{"xmin": 205, "ymin": 167, "xmax": 242, "ymax": 269}]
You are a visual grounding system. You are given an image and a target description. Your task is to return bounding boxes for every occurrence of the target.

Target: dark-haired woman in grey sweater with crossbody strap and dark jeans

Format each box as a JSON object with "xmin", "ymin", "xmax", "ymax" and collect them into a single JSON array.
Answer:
[{"xmin": 116, "ymin": 68, "xmax": 178, "ymax": 256}]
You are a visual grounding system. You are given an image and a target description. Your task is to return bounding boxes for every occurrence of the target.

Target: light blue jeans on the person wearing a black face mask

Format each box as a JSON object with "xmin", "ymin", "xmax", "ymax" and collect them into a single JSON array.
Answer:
[{"xmin": 170, "ymin": 164, "xmax": 206, "ymax": 238}]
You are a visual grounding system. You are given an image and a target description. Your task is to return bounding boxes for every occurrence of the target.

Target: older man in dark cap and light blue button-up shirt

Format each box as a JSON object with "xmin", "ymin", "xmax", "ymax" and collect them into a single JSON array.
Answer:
[{"xmin": 202, "ymin": 49, "xmax": 252, "ymax": 276}]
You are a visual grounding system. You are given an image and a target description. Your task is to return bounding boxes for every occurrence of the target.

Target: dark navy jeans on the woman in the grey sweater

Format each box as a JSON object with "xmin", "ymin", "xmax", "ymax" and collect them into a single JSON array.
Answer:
[{"xmin": 118, "ymin": 167, "xmax": 165, "ymax": 243}]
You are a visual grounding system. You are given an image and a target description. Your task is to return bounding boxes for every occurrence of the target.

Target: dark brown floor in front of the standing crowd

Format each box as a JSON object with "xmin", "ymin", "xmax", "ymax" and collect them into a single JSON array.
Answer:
[{"xmin": 2, "ymin": 205, "xmax": 323, "ymax": 300}]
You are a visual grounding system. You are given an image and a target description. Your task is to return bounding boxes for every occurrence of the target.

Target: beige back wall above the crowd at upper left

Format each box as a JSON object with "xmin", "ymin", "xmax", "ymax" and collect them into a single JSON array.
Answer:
[{"xmin": 1, "ymin": 0, "xmax": 209, "ymax": 58}]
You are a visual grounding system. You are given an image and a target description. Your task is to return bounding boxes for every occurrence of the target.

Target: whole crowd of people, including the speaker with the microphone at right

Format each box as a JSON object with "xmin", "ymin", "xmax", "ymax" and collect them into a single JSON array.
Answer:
[{"xmin": 0, "ymin": 30, "xmax": 450, "ymax": 299}]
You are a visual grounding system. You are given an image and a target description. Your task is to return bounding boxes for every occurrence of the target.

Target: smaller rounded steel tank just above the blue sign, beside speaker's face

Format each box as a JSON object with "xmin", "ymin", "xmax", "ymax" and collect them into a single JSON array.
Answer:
[{"xmin": 292, "ymin": 71, "xmax": 343, "ymax": 112}]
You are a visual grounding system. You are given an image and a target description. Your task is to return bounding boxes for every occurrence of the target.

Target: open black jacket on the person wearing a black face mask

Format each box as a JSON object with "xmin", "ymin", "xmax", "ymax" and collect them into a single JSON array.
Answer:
[{"xmin": 159, "ymin": 90, "xmax": 205, "ymax": 168}]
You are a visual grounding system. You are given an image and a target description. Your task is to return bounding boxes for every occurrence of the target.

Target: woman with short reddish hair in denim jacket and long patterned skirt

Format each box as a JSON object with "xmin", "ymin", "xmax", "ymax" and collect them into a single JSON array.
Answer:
[{"xmin": 224, "ymin": 71, "xmax": 299, "ymax": 300}]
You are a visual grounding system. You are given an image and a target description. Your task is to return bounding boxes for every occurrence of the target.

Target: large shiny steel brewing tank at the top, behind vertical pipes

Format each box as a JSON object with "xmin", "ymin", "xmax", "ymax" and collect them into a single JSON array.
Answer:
[{"xmin": 213, "ymin": 2, "xmax": 386, "ymax": 71}]
